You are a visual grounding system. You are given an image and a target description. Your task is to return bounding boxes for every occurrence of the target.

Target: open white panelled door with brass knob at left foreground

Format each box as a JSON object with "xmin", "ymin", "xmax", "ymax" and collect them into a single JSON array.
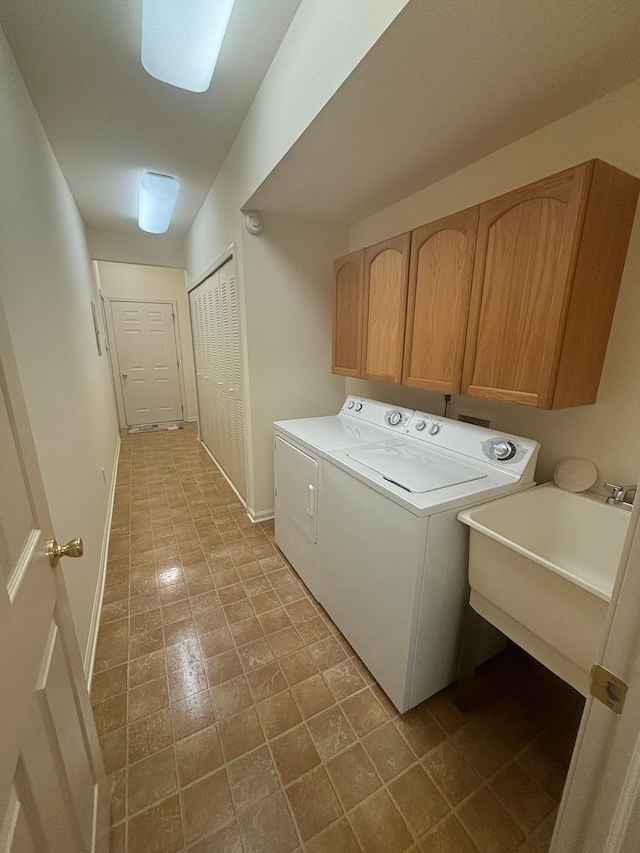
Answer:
[{"xmin": 0, "ymin": 294, "xmax": 109, "ymax": 853}]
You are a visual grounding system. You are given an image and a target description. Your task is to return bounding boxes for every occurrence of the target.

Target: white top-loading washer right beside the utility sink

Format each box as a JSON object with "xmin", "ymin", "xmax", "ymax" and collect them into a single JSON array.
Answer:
[{"xmin": 317, "ymin": 410, "xmax": 539, "ymax": 713}]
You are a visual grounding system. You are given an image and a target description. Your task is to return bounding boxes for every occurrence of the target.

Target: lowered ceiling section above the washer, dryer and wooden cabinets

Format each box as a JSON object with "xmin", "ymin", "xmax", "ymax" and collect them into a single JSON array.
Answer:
[{"xmin": 246, "ymin": 0, "xmax": 640, "ymax": 224}]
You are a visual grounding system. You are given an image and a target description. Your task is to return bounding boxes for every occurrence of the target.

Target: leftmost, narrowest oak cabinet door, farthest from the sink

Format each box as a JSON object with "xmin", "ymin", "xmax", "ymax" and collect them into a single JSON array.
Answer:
[{"xmin": 332, "ymin": 249, "xmax": 364, "ymax": 376}]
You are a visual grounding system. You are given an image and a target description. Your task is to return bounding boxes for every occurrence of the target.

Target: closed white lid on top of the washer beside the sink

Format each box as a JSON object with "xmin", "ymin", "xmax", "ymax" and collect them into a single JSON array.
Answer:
[{"xmin": 347, "ymin": 442, "xmax": 487, "ymax": 494}]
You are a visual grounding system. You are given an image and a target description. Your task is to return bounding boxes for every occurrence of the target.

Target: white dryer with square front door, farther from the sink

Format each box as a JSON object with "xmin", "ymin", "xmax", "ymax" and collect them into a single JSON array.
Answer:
[{"xmin": 274, "ymin": 395, "xmax": 413, "ymax": 600}]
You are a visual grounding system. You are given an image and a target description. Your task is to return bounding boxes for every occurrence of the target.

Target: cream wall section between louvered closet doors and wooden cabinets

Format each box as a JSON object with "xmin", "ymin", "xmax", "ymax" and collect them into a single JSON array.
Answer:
[{"xmin": 244, "ymin": 216, "xmax": 347, "ymax": 514}]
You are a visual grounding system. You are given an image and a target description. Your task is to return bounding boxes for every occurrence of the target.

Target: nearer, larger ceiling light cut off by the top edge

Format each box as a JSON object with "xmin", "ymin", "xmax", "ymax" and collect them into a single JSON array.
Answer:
[{"xmin": 142, "ymin": 0, "xmax": 234, "ymax": 92}]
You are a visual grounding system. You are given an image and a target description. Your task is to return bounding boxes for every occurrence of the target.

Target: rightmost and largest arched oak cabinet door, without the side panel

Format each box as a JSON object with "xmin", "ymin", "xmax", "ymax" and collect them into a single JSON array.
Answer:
[{"xmin": 462, "ymin": 164, "xmax": 589, "ymax": 407}]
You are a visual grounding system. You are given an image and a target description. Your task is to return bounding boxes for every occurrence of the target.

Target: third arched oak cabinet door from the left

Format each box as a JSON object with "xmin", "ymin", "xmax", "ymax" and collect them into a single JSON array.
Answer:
[{"xmin": 402, "ymin": 207, "xmax": 478, "ymax": 393}]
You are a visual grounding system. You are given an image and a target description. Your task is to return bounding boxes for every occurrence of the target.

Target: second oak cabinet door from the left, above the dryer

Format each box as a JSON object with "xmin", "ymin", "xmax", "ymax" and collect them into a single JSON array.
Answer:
[{"xmin": 362, "ymin": 234, "xmax": 411, "ymax": 383}]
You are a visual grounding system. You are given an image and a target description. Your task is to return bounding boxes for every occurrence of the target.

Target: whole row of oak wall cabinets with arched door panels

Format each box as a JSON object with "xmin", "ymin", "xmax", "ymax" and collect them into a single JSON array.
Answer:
[{"xmin": 333, "ymin": 160, "xmax": 640, "ymax": 409}]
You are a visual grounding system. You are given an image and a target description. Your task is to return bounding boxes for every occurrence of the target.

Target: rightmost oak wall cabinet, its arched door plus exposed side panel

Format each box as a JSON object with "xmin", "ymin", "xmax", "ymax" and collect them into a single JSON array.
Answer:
[{"xmin": 462, "ymin": 160, "xmax": 640, "ymax": 409}]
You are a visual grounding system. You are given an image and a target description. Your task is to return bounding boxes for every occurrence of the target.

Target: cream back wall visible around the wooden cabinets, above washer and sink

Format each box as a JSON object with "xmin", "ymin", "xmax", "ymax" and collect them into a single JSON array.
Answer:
[{"xmin": 346, "ymin": 81, "xmax": 640, "ymax": 489}]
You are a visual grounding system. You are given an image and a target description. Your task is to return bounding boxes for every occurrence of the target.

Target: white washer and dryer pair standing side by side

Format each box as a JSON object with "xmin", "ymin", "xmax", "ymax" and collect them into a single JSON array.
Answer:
[{"xmin": 274, "ymin": 396, "xmax": 539, "ymax": 713}]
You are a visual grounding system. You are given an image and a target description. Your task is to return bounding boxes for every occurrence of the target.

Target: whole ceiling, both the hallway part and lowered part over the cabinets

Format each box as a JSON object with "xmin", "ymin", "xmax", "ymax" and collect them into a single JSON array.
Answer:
[{"xmin": 0, "ymin": 0, "xmax": 640, "ymax": 239}]
